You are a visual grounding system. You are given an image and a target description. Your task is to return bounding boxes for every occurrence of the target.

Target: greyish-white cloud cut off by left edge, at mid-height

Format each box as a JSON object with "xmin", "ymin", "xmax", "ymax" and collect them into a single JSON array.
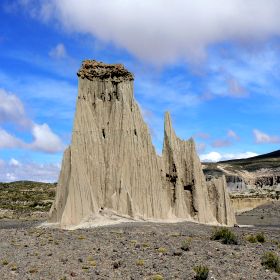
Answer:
[{"xmin": 0, "ymin": 89, "xmax": 30, "ymax": 126}]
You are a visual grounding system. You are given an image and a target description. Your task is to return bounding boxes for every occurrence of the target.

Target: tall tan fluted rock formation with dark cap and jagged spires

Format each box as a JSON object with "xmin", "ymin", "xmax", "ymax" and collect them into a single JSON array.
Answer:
[{"xmin": 49, "ymin": 60, "xmax": 234, "ymax": 228}]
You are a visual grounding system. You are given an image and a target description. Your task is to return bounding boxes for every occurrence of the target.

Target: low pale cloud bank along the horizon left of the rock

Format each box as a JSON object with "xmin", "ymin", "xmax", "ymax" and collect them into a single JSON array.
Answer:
[{"xmin": 0, "ymin": 159, "xmax": 60, "ymax": 182}]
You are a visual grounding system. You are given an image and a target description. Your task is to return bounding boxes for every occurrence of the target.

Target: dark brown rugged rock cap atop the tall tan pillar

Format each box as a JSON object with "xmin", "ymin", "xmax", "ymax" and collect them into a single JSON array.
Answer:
[{"xmin": 77, "ymin": 60, "xmax": 134, "ymax": 82}]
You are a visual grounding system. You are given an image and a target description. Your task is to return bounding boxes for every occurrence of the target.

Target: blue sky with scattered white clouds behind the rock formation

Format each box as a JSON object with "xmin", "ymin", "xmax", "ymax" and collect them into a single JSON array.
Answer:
[{"xmin": 0, "ymin": 0, "xmax": 280, "ymax": 181}]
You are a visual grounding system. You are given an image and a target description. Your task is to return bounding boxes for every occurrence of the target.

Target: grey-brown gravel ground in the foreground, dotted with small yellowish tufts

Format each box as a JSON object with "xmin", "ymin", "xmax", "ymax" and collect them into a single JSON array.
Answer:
[{"xmin": 0, "ymin": 217, "xmax": 280, "ymax": 280}]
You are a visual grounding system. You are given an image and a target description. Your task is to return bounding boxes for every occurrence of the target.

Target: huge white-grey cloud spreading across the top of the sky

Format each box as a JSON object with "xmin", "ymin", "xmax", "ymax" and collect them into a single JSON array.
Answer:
[{"xmin": 20, "ymin": 0, "xmax": 280, "ymax": 64}]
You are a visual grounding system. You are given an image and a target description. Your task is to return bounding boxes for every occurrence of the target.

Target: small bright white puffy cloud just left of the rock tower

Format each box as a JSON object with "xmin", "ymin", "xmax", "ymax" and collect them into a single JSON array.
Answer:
[{"xmin": 30, "ymin": 123, "xmax": 64, "ymax": 153}]
